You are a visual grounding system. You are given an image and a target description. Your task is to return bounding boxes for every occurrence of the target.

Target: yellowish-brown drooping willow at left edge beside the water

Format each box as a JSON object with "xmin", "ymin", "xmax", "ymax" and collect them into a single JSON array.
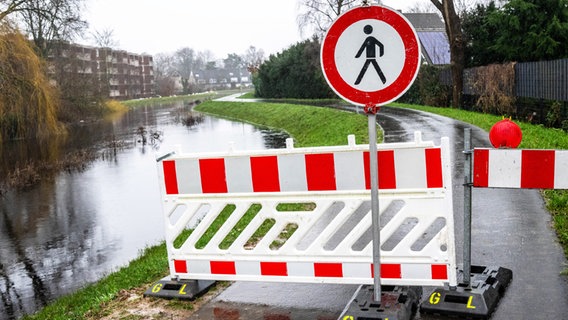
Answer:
[{"xmin": 0, "ymin": 24, "xmax": 64, "ymax": 141}]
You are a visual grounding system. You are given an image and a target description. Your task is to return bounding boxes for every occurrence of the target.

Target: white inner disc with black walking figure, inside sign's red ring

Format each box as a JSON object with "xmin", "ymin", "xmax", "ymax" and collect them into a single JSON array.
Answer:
[{"xmin": 335, "ymin": 19, "xmax": 405, "ymax": 92}]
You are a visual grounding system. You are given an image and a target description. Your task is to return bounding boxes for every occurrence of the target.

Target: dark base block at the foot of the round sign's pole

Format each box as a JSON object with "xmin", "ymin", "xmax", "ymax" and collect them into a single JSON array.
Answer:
[{"xmin": 339, "ymin": 285, "xmax": 422, "ymax": 320}]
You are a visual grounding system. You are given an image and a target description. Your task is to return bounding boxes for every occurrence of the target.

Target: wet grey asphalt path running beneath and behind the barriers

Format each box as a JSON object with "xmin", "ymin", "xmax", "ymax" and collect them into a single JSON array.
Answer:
[{"xmin": 190, "ymin": 104, "xmax": 568, "ymax": 320}]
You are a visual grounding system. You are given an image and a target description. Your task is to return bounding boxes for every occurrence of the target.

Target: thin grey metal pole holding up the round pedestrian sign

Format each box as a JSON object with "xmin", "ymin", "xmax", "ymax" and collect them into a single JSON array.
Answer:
[{"xmin": 367, "ymin": 107, "xmax": 381, "ymax": 303}]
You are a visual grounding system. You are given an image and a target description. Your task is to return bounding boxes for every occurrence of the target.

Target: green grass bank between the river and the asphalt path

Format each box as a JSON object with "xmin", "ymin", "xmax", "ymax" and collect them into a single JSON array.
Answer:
[{"xmin": 24, "ymin": 97, "xmax": 367, "ymax": 320}]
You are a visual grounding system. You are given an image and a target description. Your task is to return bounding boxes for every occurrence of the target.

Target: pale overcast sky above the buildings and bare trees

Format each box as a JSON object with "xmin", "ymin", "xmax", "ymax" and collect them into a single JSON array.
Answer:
[{"xmin": 83, "ymin": 0, "xmax": 418, "ymax": 59}]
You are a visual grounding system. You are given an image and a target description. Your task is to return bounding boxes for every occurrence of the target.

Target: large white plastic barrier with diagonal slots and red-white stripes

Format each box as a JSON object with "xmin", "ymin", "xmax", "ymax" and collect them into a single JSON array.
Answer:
[{"xmin": 159, "ymin": 135, "xmax": 457, "ymax": 285}]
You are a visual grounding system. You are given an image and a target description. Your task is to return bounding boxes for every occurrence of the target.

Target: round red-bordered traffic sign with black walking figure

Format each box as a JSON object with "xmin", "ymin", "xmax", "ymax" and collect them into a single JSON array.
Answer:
[{"xmin": 321, "ymin": 5, "xmax": 420, "ymax": 106}]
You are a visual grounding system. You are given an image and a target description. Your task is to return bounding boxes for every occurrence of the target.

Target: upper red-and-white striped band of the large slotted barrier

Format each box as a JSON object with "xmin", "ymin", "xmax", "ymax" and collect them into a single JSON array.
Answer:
[{"xmin": 162, "ymin": 139, "xmax": 443, "ymax": 195}]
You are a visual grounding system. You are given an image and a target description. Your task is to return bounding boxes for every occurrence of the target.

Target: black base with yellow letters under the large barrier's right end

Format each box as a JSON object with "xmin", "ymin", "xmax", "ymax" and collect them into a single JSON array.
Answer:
[{"xmin": 420, "ymin": 266, "xmax": 513, "ymax": 319}]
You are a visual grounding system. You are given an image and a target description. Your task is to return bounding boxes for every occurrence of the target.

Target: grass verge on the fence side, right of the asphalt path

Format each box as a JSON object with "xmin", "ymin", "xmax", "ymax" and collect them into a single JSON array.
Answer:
[{"xmin": 393, "ymin": 103, "xmax": 568, "ymax": 260}]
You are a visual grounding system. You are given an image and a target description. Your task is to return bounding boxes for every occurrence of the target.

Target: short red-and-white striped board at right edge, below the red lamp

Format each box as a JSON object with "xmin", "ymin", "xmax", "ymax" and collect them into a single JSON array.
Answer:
[{"xmin": 473, "ymin": 149, "xmax": 568, "ymax": 189}]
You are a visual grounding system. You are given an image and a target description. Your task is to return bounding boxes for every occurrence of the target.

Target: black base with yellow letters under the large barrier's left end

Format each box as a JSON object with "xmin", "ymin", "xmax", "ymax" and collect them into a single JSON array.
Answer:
[{"xmin": 144, "ymin": 277, "xmax": 215, "ymax": 300}]
